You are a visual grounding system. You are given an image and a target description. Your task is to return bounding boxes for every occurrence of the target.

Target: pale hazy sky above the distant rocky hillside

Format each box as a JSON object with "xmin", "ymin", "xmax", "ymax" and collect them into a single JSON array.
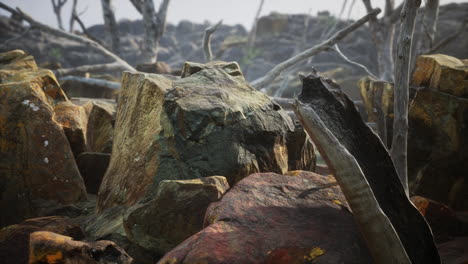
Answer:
[{"xmin": 0, "ymin": 0, "xmax": 468, "ymax": 29}]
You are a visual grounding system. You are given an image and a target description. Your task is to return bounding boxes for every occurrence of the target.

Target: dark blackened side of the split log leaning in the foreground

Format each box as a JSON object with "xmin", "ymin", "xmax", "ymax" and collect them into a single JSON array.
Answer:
[{"xmin": 299, "ymin": 71, "xmax": 440, "ymax": 264}]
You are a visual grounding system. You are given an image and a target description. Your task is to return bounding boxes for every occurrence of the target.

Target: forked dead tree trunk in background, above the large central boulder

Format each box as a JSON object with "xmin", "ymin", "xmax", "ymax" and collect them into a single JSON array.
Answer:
[{"xmin": 130, "ymin": 0, "xmax": 170, "ymax": 62}]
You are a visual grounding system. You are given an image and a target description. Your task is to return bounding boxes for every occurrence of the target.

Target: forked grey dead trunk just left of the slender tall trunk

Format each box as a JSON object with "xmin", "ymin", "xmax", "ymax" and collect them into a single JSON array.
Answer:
[{"xmin": 362, "ymin": 0, "xmax": 401, "ymax": 82}]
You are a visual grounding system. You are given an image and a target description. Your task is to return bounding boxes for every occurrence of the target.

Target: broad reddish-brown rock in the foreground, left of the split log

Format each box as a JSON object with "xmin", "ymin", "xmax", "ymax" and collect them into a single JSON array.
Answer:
[{"xmin": 158, "ymin": 172, "xmax": 372, "ymax": 264}]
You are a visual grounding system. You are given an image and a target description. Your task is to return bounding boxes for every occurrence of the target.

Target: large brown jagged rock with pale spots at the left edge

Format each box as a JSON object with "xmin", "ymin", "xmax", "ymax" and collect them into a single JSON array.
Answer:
[{"xmin": 0, "ymin": 51, "xmax": 86, "ymax": 226}]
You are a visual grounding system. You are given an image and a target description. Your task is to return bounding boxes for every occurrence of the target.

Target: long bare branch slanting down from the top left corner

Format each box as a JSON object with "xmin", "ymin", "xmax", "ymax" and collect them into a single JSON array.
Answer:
[{"xmin": 0, "ymin": 2, "xmax": 136, "ymax": 71}]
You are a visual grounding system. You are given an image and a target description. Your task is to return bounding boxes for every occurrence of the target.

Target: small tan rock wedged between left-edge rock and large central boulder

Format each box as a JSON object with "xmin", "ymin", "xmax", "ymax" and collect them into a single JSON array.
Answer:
[{"xmin": 54, "ymin": 101, "xmax": 88, "ymax": 157}]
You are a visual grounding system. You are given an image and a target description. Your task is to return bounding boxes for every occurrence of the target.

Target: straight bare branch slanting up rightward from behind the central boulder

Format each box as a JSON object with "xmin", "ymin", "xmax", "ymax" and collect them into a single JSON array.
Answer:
[{"xmin": 251, "ymin": 8, "xmax": 381, "ymax": 90}]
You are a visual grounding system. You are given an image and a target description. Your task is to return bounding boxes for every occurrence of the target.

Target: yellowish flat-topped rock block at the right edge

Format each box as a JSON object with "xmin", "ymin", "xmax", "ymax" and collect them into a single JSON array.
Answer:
[{"xmin": 412, "ymin": 54, "xmax": 468, "ymax": 98}]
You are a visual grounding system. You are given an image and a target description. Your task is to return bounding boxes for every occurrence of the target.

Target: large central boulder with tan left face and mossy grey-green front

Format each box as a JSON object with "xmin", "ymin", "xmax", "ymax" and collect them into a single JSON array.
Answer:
[{"xmin": 98, "ymin": 62, "xmax": 309, "ymax": 210}]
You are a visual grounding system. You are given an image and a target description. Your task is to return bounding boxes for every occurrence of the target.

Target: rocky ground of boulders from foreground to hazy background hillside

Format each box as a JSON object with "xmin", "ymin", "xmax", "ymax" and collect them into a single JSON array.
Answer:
[{"xmin": 0, "ymin": 4, "xmax": 468, "ymax": 264}]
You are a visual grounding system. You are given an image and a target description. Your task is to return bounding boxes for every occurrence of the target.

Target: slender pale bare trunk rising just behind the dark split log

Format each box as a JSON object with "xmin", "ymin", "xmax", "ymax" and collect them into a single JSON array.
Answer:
[{"xmin": 390, "ymin": 0, "xmax": 421, "ymax": 195}]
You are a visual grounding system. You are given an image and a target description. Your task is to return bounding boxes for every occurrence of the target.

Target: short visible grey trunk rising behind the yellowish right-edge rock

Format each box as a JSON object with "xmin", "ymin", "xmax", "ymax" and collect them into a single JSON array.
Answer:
[{"xmin": 417, "ymin": 0, "xmax": 439, "ymax": 54}]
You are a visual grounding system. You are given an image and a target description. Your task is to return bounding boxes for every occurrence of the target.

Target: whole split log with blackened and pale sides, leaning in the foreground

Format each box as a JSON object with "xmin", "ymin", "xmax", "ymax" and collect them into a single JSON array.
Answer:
[{"xmin": 295, "ymin": 73, "xmax": 440, "ymax": 264}]
